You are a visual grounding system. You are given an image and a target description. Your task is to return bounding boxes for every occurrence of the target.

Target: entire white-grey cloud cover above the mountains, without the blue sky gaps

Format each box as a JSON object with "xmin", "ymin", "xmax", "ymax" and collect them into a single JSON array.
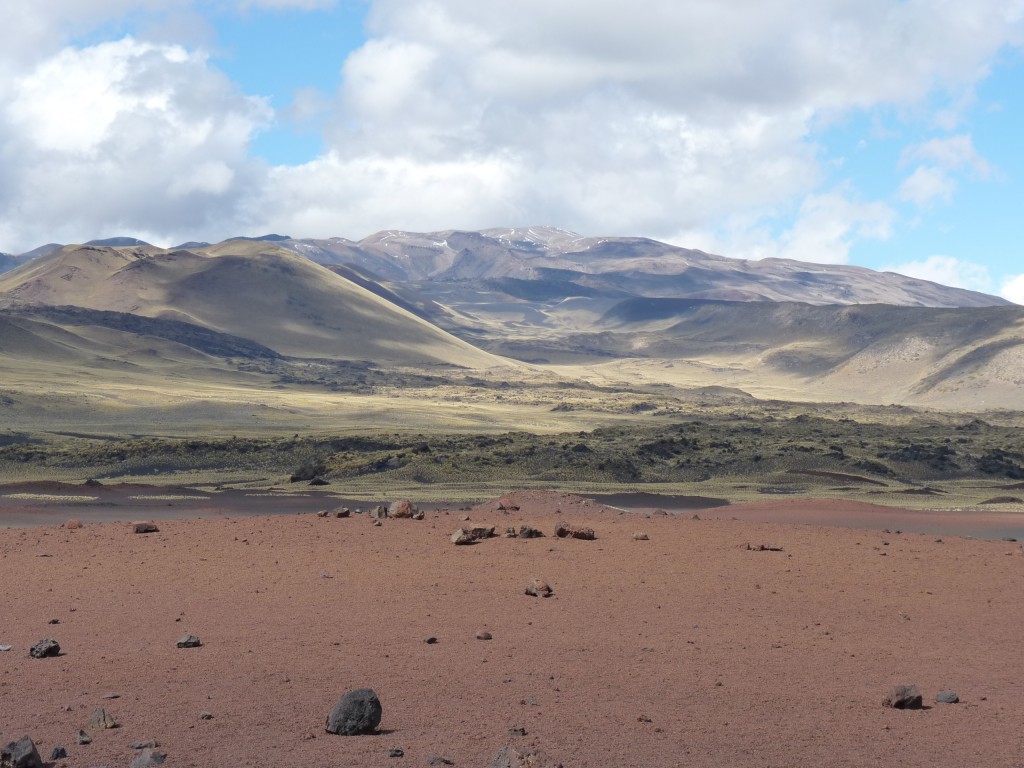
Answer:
[{"xmin": 0, "ymin": 0, "xmax": 1024, "ymax": 252}]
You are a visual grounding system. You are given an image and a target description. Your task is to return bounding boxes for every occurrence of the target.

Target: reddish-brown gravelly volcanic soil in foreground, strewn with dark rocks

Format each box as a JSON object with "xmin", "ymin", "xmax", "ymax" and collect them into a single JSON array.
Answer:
[{"xmin": 0, "ymin": 493, "xmax": 1024, "ymax": 768}]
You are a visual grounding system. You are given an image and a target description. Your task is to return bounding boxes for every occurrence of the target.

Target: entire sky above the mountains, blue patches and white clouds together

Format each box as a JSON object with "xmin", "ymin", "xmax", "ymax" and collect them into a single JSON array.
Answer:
[{"xmin": 0, "ymin": 0, "xmax": 1024, "ymax": 303}]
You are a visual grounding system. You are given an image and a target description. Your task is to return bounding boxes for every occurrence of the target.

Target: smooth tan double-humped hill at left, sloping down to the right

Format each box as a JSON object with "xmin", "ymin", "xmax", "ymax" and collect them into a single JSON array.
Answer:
[{"xmin": 0, "ymin": 241, "xmax": 508, "ymax": 368}]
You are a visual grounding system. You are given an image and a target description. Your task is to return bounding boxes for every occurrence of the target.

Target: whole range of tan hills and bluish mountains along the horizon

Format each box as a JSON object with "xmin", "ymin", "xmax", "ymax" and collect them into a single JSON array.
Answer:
[{"xmin": 0, "ymin": 227, "xmax": 1024, "ymax": 410}]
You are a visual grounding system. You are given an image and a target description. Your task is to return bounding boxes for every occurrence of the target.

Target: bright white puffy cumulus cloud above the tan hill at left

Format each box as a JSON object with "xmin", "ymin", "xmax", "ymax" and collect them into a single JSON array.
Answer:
[{"xmin": 0, "ymin": 38, "xmax": 268, "ymax": 244}]
